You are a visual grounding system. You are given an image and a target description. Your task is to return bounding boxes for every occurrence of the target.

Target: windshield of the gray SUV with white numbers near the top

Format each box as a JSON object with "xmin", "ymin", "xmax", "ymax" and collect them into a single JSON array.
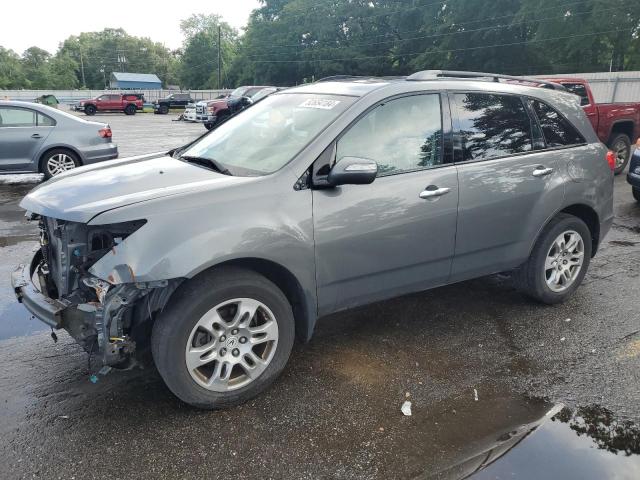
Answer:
[{"xmin": 182, "ymin": 94, "xmax": 354, "ymax": 176}]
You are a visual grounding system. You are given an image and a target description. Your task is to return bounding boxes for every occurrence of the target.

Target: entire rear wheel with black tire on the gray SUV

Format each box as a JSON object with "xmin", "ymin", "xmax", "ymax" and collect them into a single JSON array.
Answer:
[{"xmin": 514, "ymin": 214, "xmax": 592, "ymax": 305}]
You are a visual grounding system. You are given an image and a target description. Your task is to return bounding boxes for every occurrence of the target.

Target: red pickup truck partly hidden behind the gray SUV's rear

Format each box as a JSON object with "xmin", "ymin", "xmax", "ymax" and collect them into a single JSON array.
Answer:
[{"xmin": 546, "ymin": 78, "xmax": 640, "ymax": 175}]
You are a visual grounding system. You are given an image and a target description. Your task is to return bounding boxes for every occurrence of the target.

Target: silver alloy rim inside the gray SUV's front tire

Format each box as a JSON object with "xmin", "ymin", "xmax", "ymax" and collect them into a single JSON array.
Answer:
[{"xmin": 185, "ymin": 298, "xmax": 278, "ymax": 392}]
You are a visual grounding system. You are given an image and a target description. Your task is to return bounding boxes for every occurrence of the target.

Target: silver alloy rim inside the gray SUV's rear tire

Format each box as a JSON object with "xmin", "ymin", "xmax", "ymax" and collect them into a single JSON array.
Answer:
[{"xmin": 544, "ymin": 230, "xmax": 584, "ymax": 293}]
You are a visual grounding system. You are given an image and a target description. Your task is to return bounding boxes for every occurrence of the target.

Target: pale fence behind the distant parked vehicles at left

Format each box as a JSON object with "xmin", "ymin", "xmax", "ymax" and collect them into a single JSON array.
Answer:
[{"xmin": 0, "ymin": 90, "xmax": 231, "ymax": 104}]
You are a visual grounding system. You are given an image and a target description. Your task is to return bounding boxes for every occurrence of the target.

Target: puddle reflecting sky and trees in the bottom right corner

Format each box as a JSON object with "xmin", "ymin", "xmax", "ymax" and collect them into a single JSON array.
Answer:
[{"xmin": 464, "ymin": 405, "xmax": 640, "ymax": 480}]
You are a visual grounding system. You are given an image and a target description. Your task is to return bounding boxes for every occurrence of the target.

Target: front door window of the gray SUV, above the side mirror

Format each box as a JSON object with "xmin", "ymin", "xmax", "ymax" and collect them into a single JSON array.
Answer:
[{"xmin": 336, "ymin": 95, "xmax": 442, "ymax": 175}]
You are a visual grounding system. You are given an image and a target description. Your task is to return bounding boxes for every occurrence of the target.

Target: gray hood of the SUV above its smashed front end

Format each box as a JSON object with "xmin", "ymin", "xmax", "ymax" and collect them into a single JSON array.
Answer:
[{"xmin": 20, "ymin": 153, "xmax": 249, "ymax": 223}]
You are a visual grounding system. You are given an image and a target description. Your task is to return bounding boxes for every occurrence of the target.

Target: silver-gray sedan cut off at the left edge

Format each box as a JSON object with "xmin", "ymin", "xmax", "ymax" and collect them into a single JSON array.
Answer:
[{"xmin": 0, "ymin": 100, "xmax": 118, "ymax": 178}]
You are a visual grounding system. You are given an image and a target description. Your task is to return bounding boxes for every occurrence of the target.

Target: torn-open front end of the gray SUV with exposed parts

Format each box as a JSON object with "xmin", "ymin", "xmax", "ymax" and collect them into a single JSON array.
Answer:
[{"xmin": 12, "ymin": 216, "xmax": 180, "ymax": 368}]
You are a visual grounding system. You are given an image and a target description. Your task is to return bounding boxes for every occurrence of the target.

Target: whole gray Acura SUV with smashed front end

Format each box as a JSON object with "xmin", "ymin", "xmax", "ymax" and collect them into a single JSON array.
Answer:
[{"xmin": 13, "ymin": 71, "xmax": 613, "ymax": 408}]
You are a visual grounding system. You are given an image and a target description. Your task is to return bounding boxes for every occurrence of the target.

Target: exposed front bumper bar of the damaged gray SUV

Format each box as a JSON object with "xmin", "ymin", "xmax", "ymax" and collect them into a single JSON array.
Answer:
[{"xmin": 11, "ymin": 255, "xmax": 68, "ymax": 329}]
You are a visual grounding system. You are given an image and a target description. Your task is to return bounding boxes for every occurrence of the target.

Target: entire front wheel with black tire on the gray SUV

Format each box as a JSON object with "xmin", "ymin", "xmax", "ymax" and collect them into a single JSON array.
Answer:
[{"xmin": 151, "ymin": 267, "xmax": 295, "ymax": 409}]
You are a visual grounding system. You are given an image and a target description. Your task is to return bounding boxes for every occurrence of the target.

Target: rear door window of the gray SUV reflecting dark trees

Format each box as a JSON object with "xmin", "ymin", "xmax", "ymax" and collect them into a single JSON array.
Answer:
[{"xmin": 454, "ymin": 93, "xmax": 533, "ymax": 161}]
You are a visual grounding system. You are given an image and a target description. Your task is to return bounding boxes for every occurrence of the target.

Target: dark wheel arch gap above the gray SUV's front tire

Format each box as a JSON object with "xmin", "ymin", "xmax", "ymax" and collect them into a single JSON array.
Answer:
[{"xmin": 193, "ymin": 257, "xmax": 317, "ymax": 342}]
